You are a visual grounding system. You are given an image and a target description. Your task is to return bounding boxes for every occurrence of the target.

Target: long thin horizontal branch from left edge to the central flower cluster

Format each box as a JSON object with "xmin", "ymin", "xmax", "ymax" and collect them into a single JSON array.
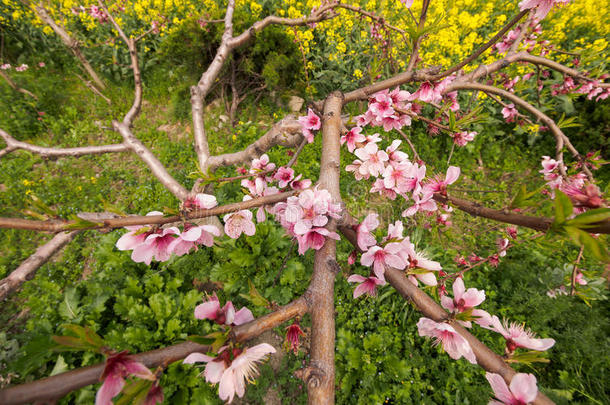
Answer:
[{"xmin": 0, "ymin": 191, "xmax": 297, "ymax": 232}]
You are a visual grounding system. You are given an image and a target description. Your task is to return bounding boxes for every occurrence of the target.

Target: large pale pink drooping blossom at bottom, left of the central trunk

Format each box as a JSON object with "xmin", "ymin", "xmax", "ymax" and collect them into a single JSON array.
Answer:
[{"xmin": 183, "ymin": 343, "xmax": 275, "ymax": 403}]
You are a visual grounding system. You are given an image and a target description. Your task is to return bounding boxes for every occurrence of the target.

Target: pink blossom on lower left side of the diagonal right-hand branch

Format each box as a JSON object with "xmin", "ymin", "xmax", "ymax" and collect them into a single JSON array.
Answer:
[{"xmin": 417, "ymin": 318, "xmax": 477, "ymax": 364}]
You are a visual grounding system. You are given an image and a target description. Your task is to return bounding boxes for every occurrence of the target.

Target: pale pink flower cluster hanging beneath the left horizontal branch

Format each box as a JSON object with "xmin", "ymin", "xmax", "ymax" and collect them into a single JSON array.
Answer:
[{"xmin": 116, "ymin": 194, "xmax": 221, "ymax": 265}]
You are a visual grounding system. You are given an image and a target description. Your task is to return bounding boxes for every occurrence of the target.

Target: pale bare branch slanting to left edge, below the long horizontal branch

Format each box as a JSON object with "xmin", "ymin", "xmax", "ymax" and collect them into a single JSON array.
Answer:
[{"xmin": 0, "ymin": 231, "xmax": 79, "ymax": 302}]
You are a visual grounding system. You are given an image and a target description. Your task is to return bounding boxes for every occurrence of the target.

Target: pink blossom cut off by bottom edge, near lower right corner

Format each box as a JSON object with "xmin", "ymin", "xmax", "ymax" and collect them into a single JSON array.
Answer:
[{"xmin": 485, "ymin": 373, "xmax": 538, "ymax": 405}]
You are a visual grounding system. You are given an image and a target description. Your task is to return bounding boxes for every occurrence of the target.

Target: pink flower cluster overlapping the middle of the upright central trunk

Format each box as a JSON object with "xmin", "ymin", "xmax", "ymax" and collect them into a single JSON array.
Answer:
[{"xmin": 273, "ymin": 187, "xmax": 341, "ymax": 254}]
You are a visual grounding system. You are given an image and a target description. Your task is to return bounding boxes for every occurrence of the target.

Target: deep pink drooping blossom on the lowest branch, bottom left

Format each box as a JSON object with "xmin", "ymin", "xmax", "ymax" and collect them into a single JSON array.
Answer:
[{"xmin": 95, "ymin": 351, "xmax": 155, "ymax": 405}]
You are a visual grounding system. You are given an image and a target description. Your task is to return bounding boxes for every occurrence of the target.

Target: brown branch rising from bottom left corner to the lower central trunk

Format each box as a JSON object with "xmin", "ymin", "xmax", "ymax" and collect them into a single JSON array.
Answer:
[{"xmin": 0, "ymin": 297, "xmax": 307, "ymax": 405}]
